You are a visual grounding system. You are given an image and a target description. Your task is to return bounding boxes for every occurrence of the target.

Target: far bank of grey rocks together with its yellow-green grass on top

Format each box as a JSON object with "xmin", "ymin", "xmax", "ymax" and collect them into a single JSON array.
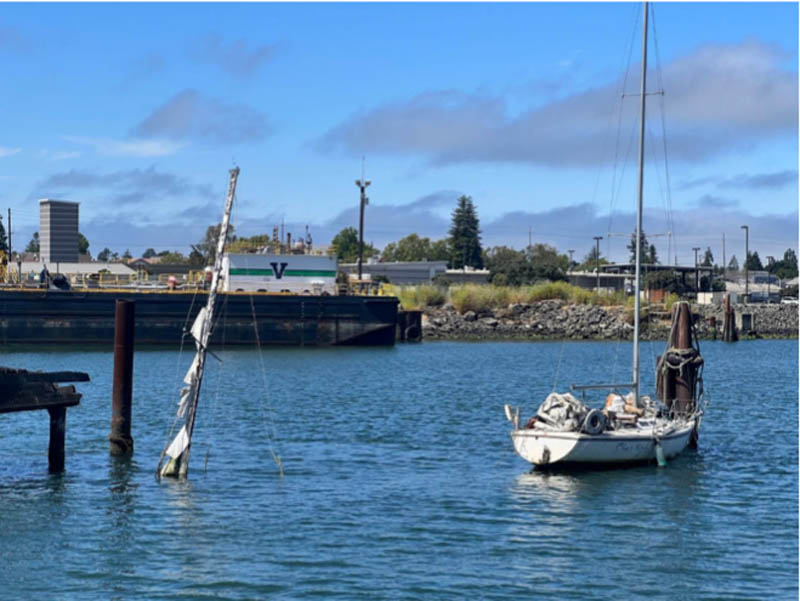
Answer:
[{"xmin": 385, "ymin": 282, "xmax": 798, "ymax": 340}]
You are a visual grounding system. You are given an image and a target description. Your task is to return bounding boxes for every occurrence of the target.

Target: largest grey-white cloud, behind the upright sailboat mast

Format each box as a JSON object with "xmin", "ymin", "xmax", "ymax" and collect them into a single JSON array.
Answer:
[{"xmin": 317, "ymin": 41, "xmax": 798, "ymax": 167}]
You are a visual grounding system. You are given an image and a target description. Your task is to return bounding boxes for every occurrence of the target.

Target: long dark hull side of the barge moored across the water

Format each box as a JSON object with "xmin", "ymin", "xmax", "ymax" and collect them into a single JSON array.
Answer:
[{"xmin": 0, "ymin": 289, "xmax": 398, "ymax": 346}]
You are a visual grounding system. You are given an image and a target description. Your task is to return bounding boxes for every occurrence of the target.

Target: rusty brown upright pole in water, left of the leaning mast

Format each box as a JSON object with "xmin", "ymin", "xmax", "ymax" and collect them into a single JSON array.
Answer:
[{"xmin": 108, "ymin": 300, "xmax": 136, "ymax": 455}]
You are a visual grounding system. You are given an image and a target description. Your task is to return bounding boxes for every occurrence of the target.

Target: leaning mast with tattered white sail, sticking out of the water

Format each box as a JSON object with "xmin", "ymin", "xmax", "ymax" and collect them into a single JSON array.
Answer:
[{"xmin": 156, "ymin": 167, "xmax": 239, "ymax": 478}]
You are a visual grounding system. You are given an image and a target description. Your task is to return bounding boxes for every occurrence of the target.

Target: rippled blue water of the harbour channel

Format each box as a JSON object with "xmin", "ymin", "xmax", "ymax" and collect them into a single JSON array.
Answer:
[{"xmin": 0, "ymin": 340, "xmax": 798, "ymax": 600}]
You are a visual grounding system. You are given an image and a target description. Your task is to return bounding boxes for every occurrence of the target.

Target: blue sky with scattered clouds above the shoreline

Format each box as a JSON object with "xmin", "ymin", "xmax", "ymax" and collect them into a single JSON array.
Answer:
[{"xmin": 0, "ymin": 2, "xmax": 798, "ymax": 265}]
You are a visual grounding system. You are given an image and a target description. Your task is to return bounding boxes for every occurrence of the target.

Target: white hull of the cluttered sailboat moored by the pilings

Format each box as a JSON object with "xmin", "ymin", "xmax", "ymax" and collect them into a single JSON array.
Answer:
[{"xmin": 511, "ymin": 420, "xmax": 695, "ymax": 465}]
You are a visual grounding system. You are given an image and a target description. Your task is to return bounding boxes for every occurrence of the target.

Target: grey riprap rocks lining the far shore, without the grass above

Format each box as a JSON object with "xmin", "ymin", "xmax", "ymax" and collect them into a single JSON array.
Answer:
[{"xmin": 422, "ymin": 300, "xmax": 798, "ymax": 340}]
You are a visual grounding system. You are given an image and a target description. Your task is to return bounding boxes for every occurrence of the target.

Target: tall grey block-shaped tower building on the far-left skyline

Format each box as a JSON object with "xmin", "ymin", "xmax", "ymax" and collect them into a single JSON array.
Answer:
[{"xmin": 39, "ymin": 198, "xmax": 78, "ymax": 265}]
